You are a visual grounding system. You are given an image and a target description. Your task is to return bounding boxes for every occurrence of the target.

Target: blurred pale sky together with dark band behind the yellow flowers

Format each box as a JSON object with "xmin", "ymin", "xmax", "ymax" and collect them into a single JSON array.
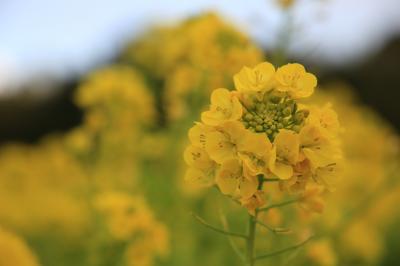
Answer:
[{"xmin": 0, "ymin": 0, "xmax": 400, "ymax": 142}]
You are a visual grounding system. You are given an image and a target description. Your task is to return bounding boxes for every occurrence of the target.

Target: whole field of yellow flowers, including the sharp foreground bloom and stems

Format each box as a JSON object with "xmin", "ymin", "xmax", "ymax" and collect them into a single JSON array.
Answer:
[{"xmin": 0, "ymin": 10, "xmax": 400, "ymax": 266}]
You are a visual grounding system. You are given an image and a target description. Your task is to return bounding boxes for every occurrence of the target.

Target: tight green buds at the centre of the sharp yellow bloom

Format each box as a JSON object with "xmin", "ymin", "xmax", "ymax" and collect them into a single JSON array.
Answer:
[{"xmin": 242, "ymin": 93, "xmax": 308, "ymax": 141}]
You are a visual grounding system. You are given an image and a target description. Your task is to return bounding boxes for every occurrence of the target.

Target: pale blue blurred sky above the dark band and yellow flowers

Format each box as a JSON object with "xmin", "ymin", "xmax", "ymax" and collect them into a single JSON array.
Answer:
[{"xmin": 0, "ymin": 0, "xmax": 400, "ymax": 92}]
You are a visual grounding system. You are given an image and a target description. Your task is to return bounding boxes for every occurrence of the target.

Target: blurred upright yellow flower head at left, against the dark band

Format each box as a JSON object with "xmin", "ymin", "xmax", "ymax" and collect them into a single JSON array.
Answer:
[{"xmin": 65, "ymin": 64, "xmax": 157, "ymax": 188}]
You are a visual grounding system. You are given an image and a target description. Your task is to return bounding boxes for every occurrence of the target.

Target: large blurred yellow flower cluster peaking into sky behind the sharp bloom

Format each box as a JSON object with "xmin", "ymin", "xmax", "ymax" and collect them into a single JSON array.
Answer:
[{"xmin": 124, "ymin": 13, "xmax": 263, "ymax": 121}]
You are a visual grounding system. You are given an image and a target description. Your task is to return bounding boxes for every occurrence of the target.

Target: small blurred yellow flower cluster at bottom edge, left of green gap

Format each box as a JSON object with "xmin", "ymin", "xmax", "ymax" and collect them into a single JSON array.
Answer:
[{"xmin": 95, "ymin": 192, "xmax": 168, "ymax": 266}]
